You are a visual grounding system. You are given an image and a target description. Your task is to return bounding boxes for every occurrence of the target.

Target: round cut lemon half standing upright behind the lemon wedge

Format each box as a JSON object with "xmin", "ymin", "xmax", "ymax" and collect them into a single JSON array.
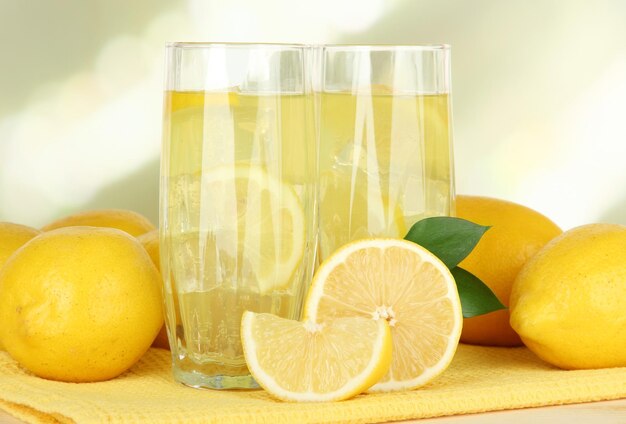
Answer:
[{"xmin": 304, "ymin": 239, "xmax": 463, "ymax": 392}]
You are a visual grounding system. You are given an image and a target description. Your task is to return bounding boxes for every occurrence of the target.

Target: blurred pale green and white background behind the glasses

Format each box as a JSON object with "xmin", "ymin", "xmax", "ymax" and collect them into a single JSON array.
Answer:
[{"xmin": 0, "ymin": 0, "xmax": 626, "ymax": 229}]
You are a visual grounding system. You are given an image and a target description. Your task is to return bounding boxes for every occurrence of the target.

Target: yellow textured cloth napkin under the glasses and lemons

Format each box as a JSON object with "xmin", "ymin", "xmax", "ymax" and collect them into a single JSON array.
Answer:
[{"xmin": 0, "ymin": 345, "xmax": 626, "ymax": 424}]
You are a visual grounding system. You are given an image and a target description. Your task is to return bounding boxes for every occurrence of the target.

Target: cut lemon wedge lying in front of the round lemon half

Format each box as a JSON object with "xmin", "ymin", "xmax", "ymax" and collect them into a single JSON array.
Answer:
[{"xmin": 241, "ymin": 311, "xmax": 392, "ymax": 402}]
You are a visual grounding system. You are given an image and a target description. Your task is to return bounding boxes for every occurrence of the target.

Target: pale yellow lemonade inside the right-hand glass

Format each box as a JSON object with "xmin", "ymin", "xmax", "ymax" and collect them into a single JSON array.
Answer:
[{"xmin": 320, "ymin": 93, "xmax": 454, "ymax": 259}]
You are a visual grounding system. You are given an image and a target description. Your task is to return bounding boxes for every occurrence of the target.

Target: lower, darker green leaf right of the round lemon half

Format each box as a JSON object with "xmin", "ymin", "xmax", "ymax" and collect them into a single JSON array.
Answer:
[{"xmin": 450, "ymin": 266, "xmax": 506, "ymax": 318}]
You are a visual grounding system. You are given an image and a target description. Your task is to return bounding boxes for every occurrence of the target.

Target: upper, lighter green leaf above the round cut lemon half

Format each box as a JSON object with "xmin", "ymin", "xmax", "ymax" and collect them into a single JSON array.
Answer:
[{"xmin": 404, "ymin": 216, "xmax": 489, "ymax": 269}]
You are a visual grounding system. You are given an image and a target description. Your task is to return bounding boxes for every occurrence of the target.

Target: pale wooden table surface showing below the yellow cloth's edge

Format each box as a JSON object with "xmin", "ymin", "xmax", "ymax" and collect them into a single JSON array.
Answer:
[{"xmin": 0, "ymin": 399, "xmax": 626, "ymax": 424}]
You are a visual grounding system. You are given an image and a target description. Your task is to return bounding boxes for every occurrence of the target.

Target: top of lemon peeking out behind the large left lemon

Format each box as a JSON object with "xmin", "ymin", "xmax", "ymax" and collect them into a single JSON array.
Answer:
[{"xmin": 42, "ymin": 209, "xmax": 155, "ymax": 237}]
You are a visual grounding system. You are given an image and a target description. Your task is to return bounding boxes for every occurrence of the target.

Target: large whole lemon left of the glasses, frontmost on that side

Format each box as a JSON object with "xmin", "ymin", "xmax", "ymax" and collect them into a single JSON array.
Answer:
[{"xmin": 0, "ymin": 227, "xmax": 163, "ymax": 382}]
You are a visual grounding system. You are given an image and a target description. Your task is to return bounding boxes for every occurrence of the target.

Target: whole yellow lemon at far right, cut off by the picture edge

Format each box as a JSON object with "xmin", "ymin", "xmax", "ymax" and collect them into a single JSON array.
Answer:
[{"xmin": 511, "ymin": 224, "xmax": 626, "ymax": 369}]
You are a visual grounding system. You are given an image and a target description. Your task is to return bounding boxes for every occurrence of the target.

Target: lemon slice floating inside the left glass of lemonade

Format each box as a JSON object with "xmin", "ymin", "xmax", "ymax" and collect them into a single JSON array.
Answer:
[{"xmin": 168, "ymin": 165, "xmax": 305, "ymax": 293}]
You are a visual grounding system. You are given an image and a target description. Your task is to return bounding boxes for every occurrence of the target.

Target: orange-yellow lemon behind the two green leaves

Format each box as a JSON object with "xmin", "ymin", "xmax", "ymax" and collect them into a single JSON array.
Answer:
[{"xmin": 456, "ymin": 195, "xmax": 562, "ymax": 346}]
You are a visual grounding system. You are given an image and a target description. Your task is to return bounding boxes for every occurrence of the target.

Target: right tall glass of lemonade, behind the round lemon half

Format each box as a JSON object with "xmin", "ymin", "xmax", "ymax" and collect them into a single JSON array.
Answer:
[{"xmin": 319, "ymin": 45, "xmax": 454, "ymax": 259}]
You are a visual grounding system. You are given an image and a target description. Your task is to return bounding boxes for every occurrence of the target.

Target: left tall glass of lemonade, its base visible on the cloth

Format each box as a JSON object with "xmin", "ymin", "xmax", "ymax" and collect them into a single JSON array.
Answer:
[{"xmin": 160, "ymin": 43, "xmax": 317, "ymax": 388}]
